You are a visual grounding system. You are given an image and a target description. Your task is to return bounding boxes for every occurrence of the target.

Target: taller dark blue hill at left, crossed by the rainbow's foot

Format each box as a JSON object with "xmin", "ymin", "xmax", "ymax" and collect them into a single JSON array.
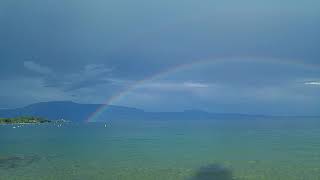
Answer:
[{"xmin": 0, "ymin": 101, "xmax": 144, "ymax": 122}]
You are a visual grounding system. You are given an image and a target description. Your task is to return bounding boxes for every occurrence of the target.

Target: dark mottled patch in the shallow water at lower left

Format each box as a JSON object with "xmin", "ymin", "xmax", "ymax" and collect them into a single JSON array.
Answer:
[{"xmin": 0, "ymin": 155, "xmax": 41, "ymax": 169}]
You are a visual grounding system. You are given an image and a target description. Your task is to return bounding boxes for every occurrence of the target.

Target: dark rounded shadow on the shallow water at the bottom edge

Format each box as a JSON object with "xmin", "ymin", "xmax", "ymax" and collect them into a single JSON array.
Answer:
[{"xmin": 188, "ymin": 164, "xmax": 235, "ymax": 180}]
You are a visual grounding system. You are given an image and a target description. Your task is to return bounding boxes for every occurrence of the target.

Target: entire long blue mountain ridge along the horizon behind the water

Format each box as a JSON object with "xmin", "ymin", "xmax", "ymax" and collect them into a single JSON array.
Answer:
[{"xmin": 0, "ymin": 101, "xmax": 312, "ymax": 122}]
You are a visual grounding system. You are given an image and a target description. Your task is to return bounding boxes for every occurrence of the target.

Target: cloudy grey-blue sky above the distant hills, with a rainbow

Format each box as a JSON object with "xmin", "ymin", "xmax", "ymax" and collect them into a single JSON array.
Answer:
[{"xmin": 0, "ymin": 0, "xmax": 320, "ymax": 115}]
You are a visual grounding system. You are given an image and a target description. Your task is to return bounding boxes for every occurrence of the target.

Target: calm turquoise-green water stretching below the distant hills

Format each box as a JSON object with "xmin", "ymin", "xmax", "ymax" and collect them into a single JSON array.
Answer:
[{"xmin": 0, "ymin": 119, "xmax": 320, "ymax": 180}]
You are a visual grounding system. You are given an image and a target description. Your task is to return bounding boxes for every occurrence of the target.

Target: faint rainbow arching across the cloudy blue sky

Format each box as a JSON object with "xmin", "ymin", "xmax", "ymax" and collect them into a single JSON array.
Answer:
[{"xmin": 86, "ymin": 57, "xmax": 319, "ymax": 122}]
